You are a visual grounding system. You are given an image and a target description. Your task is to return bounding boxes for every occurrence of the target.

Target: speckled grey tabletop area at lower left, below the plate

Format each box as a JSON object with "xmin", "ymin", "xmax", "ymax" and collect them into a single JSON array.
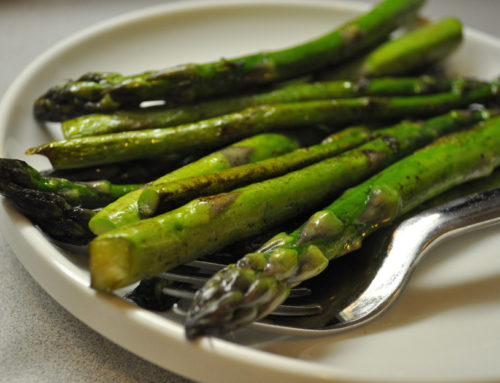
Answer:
[{"xmin": 0, "ymin": 243, "xmax": 195, "ymax": 383}]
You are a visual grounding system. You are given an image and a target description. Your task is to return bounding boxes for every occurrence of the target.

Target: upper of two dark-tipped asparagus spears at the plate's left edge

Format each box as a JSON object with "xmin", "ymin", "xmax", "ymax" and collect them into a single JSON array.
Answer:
[{"xmin": 0, "ymin": 158, "xmax": 141, "ymax": 209}]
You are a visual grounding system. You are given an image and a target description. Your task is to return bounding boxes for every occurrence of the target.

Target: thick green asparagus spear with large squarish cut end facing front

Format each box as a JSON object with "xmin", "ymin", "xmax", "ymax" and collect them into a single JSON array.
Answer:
[{"xmin": 89, "ymin": 111, "xmax": 489, "ymax": 291}]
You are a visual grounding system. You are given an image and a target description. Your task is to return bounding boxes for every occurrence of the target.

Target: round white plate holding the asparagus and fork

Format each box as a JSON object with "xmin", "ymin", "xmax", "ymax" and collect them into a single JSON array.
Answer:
[{"xmin": 0, "ymin": 0, "xmax": 500, "ymax": 383}]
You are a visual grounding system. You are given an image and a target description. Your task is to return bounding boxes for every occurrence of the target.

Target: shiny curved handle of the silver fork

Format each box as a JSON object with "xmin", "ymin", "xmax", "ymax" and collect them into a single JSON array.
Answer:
[{"xmin": 331, "ymin": 189, "xmax": 500, "ymax": 331}]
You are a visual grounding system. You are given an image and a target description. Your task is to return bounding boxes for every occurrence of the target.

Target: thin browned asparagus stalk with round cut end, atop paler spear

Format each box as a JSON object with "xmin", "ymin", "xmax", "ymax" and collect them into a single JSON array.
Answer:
[{"xmin": 138, "ymin": 126, "xmax": 386, "ymax": 218}]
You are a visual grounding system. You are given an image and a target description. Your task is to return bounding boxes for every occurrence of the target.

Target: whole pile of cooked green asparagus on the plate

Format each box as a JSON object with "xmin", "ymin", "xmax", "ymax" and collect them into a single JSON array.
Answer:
[{"xmin": 0, "ymin": 0, "xmax": 500, "ymax": 339}]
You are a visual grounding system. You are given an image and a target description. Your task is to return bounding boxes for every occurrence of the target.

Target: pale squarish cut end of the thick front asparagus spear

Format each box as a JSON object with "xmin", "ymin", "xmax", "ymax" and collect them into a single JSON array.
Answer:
[{"xmin": 90, "ymin": 238, "xmax": 131, "ymax": 291}]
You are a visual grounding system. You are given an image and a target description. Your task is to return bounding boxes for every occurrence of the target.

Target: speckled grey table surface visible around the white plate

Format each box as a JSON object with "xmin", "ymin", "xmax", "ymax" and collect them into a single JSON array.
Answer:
[{"xmin": 0, "ymin": 0, "xmax": 500, "ymax": 383}]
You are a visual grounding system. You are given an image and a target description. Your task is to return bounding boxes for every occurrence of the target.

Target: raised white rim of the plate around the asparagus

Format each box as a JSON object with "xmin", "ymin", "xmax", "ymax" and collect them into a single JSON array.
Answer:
[{"xmin": 0, "ymin": 0, "xmax": 500, "ymax": 383}]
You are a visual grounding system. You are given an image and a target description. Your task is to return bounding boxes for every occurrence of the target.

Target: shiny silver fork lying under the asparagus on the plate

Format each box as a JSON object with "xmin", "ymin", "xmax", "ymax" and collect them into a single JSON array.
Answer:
[{"xmin": 129, "ymin": 189, "xmax": 500, "ymax": 335}]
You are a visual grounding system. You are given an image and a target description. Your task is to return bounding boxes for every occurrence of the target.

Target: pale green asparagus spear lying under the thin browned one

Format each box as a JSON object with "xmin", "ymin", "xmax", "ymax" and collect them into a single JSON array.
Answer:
[{"xmin": 89, "ymin": 134, "xmax": 297, "ymax": 234}]
